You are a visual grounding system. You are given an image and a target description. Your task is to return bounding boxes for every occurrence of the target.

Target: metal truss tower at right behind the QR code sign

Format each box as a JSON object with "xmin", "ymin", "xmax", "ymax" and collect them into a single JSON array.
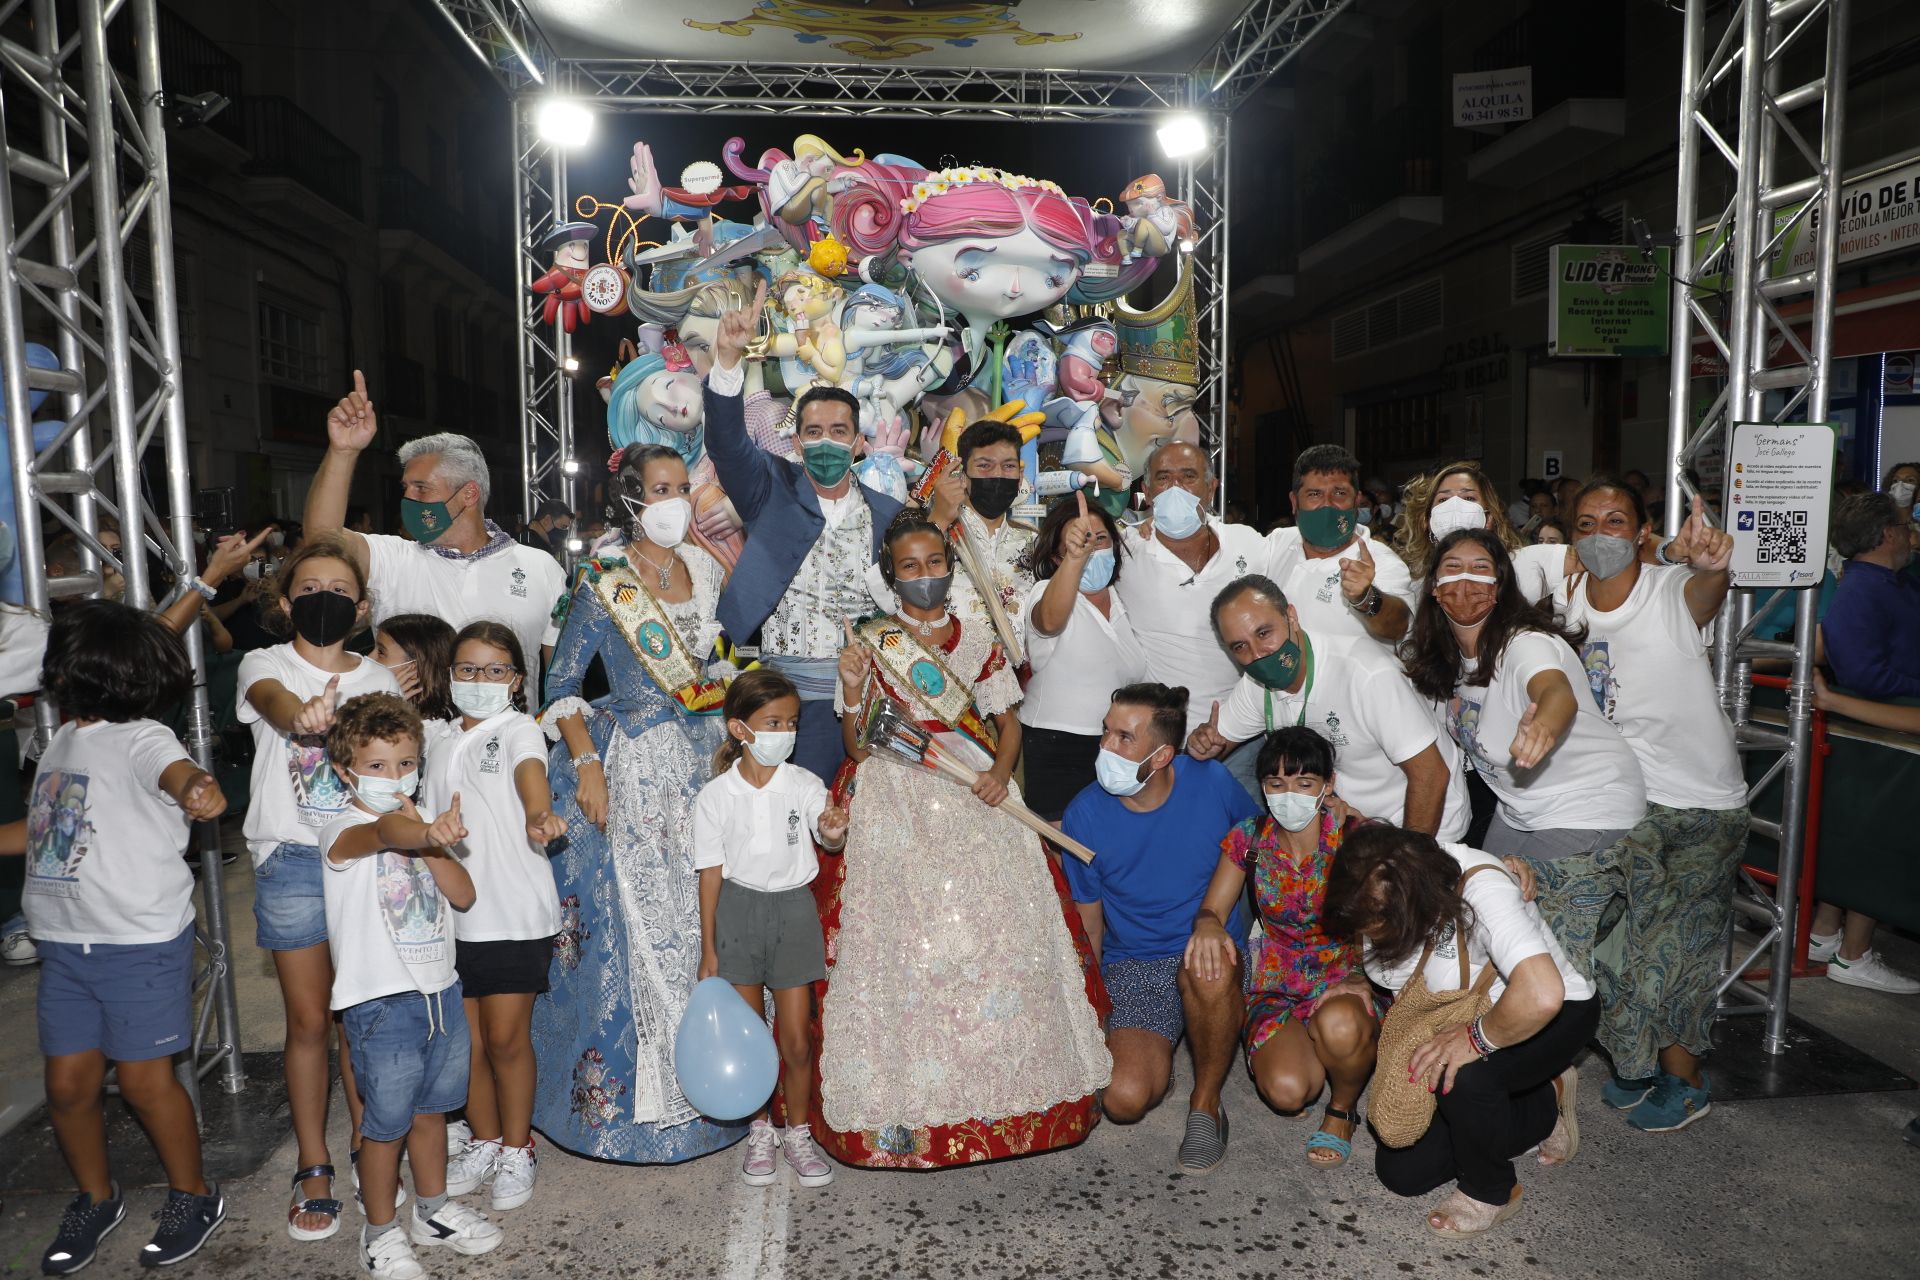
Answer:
[{"xmin": 1667, "ymin": 0, "xmax": 1849, "ymax": 1054}]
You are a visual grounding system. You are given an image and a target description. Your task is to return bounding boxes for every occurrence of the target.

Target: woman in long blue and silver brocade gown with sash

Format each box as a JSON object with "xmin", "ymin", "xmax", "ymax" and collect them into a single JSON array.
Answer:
[{"xmin": 534, "ymin": 445, "xmax": 747, "ymax": 1163}]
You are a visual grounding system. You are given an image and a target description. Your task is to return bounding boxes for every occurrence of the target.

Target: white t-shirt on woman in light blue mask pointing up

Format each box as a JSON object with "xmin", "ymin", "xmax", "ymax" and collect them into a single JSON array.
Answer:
[{"xmin": 1020, "ymin": 572, "xmax": 1146, "ymax": 735}]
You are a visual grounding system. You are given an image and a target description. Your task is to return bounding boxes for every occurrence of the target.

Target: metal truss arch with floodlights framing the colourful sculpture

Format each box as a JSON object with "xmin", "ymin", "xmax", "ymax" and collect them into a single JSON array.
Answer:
[{"xmin": 434, "ymin": 0, "xmax": 1348, "ymax": 516}]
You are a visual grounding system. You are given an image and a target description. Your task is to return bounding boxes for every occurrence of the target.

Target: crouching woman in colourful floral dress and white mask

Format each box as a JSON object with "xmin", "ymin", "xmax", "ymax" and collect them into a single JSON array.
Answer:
[{"xmin": 1187, "ymin": 727, "xmax": 1379, "ymax": 1165}]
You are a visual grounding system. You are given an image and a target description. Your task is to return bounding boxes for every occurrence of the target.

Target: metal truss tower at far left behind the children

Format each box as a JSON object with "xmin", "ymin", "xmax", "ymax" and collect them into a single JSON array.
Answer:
[{"xmin": 0, "ymin": 0, "xmax": 246, "ymax": 1098}]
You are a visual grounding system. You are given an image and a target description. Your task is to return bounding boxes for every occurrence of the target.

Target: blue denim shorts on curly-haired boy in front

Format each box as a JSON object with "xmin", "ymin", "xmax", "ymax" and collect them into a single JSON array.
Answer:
[{"xmin": 340, "ymin": 981, "xmax": 470, "ymax": 1142}]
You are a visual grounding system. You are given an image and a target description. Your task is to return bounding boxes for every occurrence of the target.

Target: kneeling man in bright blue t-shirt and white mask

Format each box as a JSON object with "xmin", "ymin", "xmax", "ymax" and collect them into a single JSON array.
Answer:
[{"xmin": 1062, "ymin": 683, "xmax": 1260, "ymax": 1173}]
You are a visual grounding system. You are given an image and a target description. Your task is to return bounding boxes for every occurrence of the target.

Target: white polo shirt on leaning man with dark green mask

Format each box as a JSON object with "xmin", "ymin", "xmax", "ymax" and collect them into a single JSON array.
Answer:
[{"xmin": 1219, "ymin": 633, "xmax": 1473, "ymax": 841}]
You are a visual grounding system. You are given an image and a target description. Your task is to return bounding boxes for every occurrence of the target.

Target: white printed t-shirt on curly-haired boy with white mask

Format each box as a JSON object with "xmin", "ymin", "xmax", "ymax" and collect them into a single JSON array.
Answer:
[{"xmin": 319, "ymin": 804, "xmax": 465, "ymax": 1009}]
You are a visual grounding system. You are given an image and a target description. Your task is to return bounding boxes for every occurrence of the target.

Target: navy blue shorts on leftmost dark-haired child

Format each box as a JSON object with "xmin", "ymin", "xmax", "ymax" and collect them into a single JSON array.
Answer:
[{"xmin": 36, "ymin": 925, "xmax": 194, "ymax": 1063}]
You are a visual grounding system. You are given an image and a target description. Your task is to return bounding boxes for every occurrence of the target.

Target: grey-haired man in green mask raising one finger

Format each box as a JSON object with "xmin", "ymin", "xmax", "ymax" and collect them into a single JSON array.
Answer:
[{"xmin": 305, "ymin": 368, "xmax": 566, "ymax": 697}]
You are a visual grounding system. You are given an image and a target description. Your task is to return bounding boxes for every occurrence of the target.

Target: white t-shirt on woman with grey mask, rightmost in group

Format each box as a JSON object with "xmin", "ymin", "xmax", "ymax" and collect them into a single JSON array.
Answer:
[{"xmin": 1553, "ymin": 566, "xmax": 1747, "ymax": 810}]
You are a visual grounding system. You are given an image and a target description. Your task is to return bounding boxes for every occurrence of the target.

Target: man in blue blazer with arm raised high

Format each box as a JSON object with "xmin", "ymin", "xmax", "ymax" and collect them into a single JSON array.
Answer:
[{"xmin": 705, "ymin": 280, "xmax": 900, "ymax": 783}]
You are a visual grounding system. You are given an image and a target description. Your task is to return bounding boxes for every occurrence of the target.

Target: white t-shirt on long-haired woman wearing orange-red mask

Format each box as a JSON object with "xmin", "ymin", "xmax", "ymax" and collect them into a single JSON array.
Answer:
[{"xmin": 1446, "ymin": 631, "xmax": 1647, "ymax": 831}]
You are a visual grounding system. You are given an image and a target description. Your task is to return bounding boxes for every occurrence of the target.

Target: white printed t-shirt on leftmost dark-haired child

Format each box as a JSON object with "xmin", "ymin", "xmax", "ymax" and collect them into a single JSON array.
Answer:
[{"xmin": 21, "ymin": 720, "xmax": 194, "ymax": 946}]
